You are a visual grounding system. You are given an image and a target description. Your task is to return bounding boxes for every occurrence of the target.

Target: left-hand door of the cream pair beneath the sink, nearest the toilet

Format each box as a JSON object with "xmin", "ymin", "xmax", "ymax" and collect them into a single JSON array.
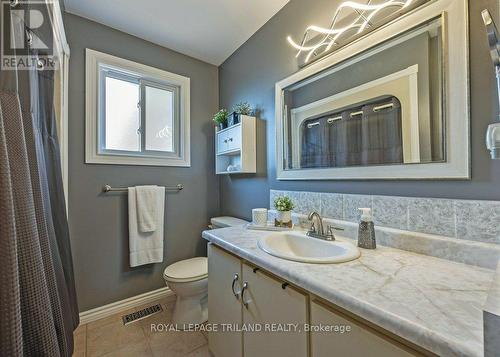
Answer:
[{"xmin": 208, "ymin": 244, "xmax": 242, "ymax": 357}]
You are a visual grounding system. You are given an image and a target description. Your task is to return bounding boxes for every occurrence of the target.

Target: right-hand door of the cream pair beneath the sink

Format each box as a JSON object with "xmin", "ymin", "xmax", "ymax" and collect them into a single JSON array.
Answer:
[{"xmin": 242, "ymin": 264, "xmax": 308, "ymax": 357}]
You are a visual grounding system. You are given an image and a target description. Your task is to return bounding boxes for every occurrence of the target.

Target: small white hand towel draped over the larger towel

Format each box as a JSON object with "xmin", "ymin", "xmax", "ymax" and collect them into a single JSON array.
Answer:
[{"xmin": 135, "ymin": 186, "xmax": 160, "ymax": 233}]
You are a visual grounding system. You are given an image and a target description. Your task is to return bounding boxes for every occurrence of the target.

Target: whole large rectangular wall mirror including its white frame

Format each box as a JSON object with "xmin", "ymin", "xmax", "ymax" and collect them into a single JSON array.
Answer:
[{"xmin": 276, "ymin": 0, "xmax": 469, "ymax": 179}]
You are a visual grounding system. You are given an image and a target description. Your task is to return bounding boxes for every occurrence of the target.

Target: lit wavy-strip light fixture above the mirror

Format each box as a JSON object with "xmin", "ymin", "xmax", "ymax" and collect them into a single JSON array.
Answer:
[{"xmin": 287, "ymin": 0, "xmax": 415, "ymax": 64}]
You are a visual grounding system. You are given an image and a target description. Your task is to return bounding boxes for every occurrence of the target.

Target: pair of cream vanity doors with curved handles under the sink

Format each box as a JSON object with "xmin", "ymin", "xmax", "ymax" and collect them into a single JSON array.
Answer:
[{"xmin": 208, "ymin": 244, "xmax": 308, "ymax": 357}]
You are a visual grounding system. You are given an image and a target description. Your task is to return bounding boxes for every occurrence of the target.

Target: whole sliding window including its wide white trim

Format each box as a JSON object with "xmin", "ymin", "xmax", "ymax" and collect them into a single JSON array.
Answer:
[{"xmin": 86, "ymin": 49, "xmax": 190, "ymax": 166}]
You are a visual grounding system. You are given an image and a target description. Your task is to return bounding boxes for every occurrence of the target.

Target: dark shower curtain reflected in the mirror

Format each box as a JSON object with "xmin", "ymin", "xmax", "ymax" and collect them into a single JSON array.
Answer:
[{"xmin": 300, "ymin": 96, "xmax": 403, "ymax": 168}]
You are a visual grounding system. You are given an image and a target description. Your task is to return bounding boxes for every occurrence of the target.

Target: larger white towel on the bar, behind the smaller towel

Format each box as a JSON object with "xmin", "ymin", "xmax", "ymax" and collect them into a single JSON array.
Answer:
[{"xmin": 128, "ymin": 187, "xmax": 165, "ymax": 267}]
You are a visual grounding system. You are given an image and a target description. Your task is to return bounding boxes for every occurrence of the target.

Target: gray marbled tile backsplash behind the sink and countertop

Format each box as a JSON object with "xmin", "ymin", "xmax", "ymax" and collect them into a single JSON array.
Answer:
[{"xmin": 269, "ymin": 190, "xmax": 500, "ymax": 244}]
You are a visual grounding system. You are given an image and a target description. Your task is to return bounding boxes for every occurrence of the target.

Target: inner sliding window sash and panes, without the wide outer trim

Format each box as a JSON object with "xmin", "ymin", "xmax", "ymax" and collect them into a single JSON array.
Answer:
[{"xmin": 98, "ymin": 66, "xmax": 179, "ymax": 156}]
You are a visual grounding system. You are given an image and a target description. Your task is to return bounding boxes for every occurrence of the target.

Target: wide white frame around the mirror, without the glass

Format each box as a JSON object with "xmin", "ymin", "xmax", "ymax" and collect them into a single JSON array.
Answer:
[{"xmin": 275, "ymin": 0, "xmax": 470, "ymax": 180}]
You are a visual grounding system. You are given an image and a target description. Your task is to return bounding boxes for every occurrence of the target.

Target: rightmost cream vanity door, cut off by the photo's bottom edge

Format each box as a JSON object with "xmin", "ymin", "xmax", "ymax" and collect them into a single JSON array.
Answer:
[{"xmin": 311, "ymin": 301, "xmax": 421, "ymax": 357}]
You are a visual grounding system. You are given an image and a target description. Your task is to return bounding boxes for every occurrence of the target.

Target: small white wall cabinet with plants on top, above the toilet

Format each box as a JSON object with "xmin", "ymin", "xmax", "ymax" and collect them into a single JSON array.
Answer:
[{"xmin": 215, "ymin": 115, "xmax": 256, "ymax": 175}]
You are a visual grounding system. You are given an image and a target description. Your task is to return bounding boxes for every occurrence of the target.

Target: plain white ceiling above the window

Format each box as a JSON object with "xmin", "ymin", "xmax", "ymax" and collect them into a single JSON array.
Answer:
[{"xmin": 64, "ymin": 0, "xmax": 289, "ymax": 65}]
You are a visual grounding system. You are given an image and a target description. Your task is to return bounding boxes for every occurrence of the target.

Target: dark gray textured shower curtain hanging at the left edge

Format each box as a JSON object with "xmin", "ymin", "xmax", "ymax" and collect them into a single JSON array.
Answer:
[{"xmin": 0, "ymin": 3, "xmax": 79, "ymax": 356}]
